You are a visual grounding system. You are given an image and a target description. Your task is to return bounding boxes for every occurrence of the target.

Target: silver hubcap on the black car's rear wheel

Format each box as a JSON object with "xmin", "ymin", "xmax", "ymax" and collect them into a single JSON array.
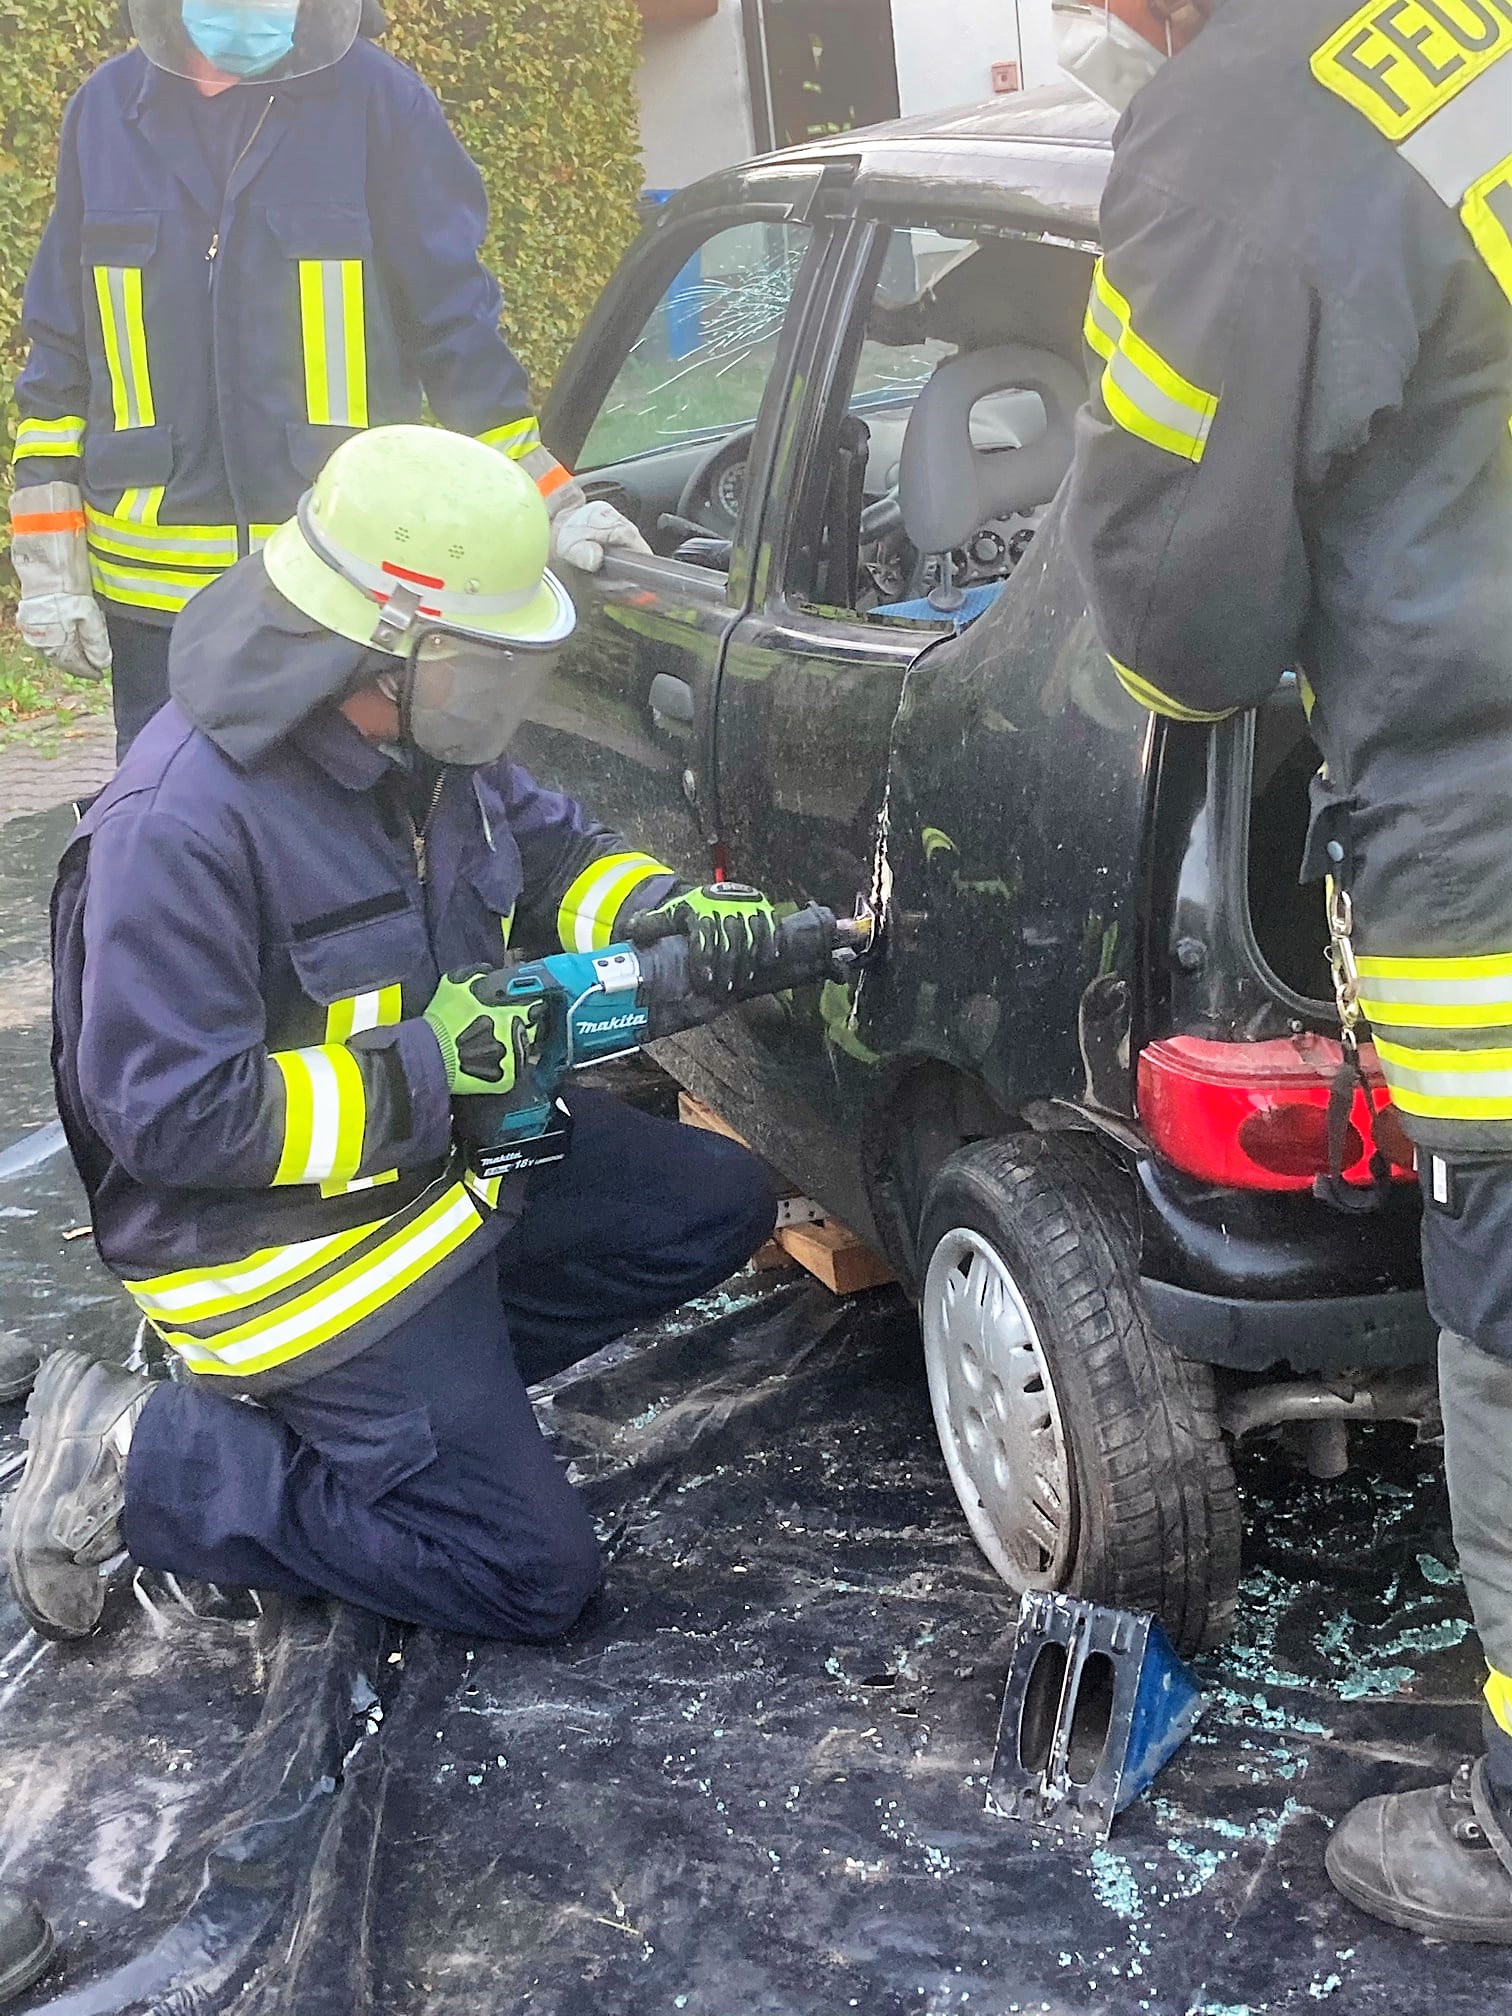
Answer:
[{"xmin": 919, "ymin": 1226, "xmax": 1073, "ymax": 1589}]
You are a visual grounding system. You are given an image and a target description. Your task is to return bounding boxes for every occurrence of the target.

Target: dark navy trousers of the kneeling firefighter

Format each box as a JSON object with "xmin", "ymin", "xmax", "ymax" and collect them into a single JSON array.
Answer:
[{"xmin": 125, "ymin": 1093, "xmax": 776, "ymax": 1639}]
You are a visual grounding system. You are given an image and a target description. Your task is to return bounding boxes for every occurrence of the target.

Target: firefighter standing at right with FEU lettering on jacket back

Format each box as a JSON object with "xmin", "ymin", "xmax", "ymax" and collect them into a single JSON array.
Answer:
[{"xmin": 1056, "ymin": 0, "xmax": 1512, "ymax": 1943}]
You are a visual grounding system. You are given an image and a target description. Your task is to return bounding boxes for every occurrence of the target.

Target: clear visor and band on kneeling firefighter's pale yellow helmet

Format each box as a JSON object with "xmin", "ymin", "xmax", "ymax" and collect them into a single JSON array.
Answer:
[{"xmin": 298, "ymin": 492, "xmax": 577, "ymax": 770}]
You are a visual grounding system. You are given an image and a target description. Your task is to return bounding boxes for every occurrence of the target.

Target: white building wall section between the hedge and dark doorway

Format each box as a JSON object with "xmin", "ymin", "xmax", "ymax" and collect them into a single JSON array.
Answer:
[{"xmin": 637, "ymin": 0, "xmax": 756, "ymax": 190}]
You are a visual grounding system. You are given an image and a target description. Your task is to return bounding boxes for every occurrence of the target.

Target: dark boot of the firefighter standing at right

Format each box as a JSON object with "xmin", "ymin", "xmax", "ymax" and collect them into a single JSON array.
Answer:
[{"xmin": 1327, "ymin": 1758, "xmax": 1512, "ymax": 1945}]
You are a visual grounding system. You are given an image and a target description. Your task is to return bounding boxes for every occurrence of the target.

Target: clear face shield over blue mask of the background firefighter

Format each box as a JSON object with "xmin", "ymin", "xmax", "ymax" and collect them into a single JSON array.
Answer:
[{"xmin": 129, "ymin": 0, "xmax": 363, "ymax": 83}]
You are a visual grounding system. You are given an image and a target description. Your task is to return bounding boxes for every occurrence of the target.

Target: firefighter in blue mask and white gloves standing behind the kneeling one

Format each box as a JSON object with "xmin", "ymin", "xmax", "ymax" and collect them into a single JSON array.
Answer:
[{"xmin": 10, "ymin": 0, "xmax": 645, "ymax": 754}]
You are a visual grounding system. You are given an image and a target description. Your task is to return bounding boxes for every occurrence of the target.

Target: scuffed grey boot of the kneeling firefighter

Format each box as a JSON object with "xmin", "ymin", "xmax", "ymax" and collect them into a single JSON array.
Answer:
[{"xmin": 6, "ymin": 1351, "xmax": 155, "ymax": 1639}]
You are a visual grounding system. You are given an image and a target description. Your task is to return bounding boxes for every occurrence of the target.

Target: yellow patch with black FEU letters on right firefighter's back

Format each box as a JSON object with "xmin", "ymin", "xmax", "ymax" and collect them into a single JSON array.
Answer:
[{"xmin": 1310, "ymin": 0, "xmax": 1512, "ymax": 141}]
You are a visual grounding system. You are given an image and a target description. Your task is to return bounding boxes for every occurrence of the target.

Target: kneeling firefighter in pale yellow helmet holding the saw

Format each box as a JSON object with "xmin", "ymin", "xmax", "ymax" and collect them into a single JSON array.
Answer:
[{"xmin": 8, "ymin": 427, "xmax": 776, "ymax": 1639}]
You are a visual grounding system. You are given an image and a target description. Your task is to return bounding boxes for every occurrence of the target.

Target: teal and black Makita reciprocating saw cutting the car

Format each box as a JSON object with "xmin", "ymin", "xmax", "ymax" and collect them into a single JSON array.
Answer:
[{"xmin": 454, "ymin": 883, "xmax": 873, "ymax": 1177}]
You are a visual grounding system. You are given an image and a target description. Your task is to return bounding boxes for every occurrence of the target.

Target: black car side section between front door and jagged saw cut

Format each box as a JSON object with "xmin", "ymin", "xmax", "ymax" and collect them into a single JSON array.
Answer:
[{"xmin": 700, "ymin": 220, "xmax": 971, "ymax": 1232}]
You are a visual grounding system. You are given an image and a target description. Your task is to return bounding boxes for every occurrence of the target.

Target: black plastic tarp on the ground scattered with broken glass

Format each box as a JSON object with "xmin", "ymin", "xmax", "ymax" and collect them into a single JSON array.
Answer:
[{"xmin": 0, "ymin": 806, "xmax": 1512, "ymax": 2016}]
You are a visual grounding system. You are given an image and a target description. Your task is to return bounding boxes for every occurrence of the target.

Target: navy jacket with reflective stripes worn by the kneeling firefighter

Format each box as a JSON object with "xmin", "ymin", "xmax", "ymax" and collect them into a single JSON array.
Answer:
[{"xmin": 52, "ymin": 685, "xmax": 675, "ymax": 1391}]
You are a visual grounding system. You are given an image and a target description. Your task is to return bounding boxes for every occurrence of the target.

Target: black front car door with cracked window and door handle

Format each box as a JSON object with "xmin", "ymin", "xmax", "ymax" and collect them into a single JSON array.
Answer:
[{"xmin": 518, "ymin": 177, "xmax": 846, "ymax": 879}]
